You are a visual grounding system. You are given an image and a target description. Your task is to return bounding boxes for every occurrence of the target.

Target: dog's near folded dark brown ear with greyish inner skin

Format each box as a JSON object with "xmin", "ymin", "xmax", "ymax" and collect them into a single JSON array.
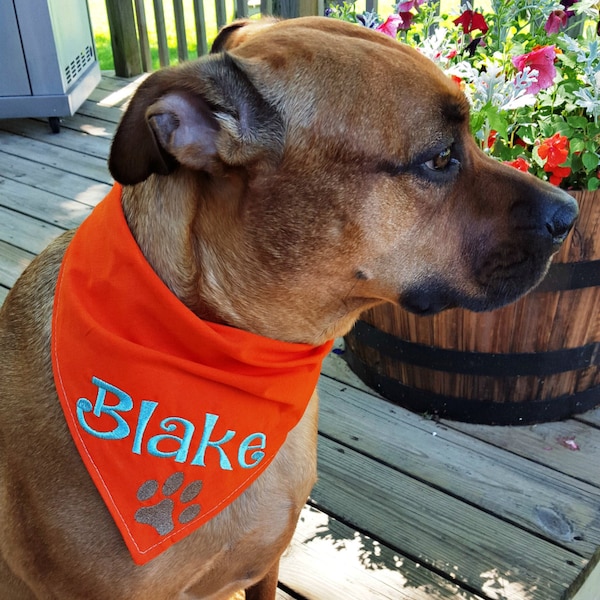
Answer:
[{"xmin": 109, "ymin": 52, "xmax": 283, "ymax": 185}]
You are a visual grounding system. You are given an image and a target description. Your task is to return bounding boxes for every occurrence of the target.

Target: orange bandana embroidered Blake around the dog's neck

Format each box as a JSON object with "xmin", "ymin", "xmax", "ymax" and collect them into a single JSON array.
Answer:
[{"xmin": 52, "ymin": 184, "xmax": 331, "ymax": 564}]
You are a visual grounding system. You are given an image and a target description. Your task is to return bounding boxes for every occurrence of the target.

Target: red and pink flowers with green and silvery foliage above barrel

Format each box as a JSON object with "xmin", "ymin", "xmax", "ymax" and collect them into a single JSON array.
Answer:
[{"xmin": 331, "ymin": 0, "xmax": 600, "ymax": 190}]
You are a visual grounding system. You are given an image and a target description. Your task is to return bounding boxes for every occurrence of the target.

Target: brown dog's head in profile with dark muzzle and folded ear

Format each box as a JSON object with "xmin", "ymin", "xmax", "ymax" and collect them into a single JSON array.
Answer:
[{"xmin": 110, "ymin": 17, "xmax": 577, "ymax": 342}]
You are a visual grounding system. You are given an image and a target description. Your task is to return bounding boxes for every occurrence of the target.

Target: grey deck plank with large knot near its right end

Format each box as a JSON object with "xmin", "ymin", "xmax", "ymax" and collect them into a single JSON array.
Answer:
[{"xmin": 319, "ymin": 377, "xmax": 600, "ymax": 558}]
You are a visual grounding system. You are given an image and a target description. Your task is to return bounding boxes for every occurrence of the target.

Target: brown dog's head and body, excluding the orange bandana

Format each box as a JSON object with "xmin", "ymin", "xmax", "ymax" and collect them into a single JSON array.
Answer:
[{"xmin": 0, "ymin": 18, "xmax": 577, "ymax": 600}]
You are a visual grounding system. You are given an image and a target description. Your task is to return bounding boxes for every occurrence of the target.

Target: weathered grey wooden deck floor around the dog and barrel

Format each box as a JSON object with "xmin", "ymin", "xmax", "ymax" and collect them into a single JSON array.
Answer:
[{"xmin": 0, "ymin": 74, "xmax": 600, "ymax": 600}]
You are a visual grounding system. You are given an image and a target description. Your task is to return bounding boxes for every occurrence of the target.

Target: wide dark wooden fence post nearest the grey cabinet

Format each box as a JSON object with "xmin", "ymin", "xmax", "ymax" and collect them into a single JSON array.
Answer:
[{"xmin": 106, "ymin": 0, "xmax": 142, "ymax": 77}]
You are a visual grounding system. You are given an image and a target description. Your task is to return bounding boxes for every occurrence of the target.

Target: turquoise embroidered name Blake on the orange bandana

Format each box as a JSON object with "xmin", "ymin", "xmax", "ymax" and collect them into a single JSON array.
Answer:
[{"xmin": 76, "ymin": 377, "xmax": 267, "ymax": 471}]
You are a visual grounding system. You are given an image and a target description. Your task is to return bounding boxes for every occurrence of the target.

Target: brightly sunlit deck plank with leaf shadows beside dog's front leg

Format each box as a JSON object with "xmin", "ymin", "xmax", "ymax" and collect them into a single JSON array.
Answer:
[{"xmin": 279, "ymin": 506, "xmax": 488, "ymax": 600}]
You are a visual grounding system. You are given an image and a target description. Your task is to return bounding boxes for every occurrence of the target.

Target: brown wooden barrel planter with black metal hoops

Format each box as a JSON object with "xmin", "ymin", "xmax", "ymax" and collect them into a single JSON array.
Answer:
[{"xmin": 345, "ymin": 191, "xmax": 600, "ymax": 425}]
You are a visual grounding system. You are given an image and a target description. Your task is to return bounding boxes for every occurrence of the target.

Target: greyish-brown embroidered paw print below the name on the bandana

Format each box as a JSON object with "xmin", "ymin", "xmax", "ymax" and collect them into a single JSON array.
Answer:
[{"xmin": 134, "ymin": 472, "xmax": 202, "ymax": 535}]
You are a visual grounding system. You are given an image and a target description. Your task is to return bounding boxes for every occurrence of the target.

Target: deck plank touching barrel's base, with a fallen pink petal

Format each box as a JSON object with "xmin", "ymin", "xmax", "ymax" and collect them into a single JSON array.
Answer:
[{"xmin": 444, "ymin": 419, "xmax": 600, "ymax": 487}]
